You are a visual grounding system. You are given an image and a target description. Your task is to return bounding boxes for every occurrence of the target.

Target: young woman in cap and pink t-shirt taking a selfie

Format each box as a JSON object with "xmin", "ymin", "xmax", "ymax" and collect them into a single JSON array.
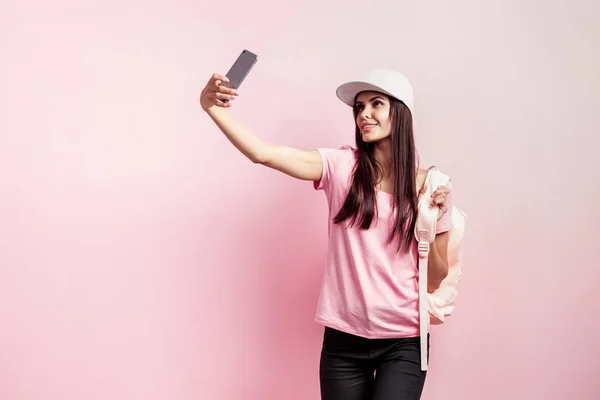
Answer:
[{"xmin": 200, "ymin": 69, "xmax": 452, "ymax": 400}]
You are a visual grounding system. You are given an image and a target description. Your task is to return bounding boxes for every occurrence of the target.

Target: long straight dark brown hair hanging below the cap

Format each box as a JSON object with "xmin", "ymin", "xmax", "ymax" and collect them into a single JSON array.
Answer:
[{"xmin": 333, "ymin": 97, "xmax": 418, "ymax": 251}]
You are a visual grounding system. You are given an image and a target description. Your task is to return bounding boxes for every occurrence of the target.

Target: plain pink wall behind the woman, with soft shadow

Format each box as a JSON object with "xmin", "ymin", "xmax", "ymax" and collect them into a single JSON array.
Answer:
[{"xmin": 0, "ymin": 0, "xmax": 600, "ymax": 400}]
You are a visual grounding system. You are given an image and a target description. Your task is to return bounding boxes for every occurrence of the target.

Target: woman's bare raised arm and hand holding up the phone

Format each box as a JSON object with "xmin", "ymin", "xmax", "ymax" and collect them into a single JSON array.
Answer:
[{"xmin": 200, "ymin": 74, "xmax": 323, "ymax": 181}]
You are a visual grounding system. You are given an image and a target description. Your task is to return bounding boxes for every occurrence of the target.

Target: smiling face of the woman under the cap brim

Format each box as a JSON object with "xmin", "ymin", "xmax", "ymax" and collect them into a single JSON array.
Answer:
[{"xmin": 354, "ymin": 92, "xmax": 392, "ymax": 143}]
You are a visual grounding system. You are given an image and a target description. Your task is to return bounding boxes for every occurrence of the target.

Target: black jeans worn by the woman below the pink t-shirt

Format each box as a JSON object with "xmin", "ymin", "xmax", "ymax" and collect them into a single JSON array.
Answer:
[{"xmin": 319, "ymin": 327, "xmax": 429, "ymax": 400}]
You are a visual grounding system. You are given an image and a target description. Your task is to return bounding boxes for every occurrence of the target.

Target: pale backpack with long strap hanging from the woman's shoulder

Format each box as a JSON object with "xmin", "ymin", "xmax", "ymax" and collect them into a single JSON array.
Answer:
[{"xmin": 415, "ymin": 166, "xmax": 467, "ymax": 371}]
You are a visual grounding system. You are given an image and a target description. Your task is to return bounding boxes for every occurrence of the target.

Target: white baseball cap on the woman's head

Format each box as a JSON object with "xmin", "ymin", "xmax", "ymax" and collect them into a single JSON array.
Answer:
[{"xmin": 335, "ymin": 68, "xmax": 414, "ymax": 113}]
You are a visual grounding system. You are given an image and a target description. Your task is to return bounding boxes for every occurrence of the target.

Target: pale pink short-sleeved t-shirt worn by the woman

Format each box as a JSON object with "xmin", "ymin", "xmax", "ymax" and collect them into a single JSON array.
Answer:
[{"xmin": 314, "ymin": 146, "xmax": 451, "ymax": 338}]
